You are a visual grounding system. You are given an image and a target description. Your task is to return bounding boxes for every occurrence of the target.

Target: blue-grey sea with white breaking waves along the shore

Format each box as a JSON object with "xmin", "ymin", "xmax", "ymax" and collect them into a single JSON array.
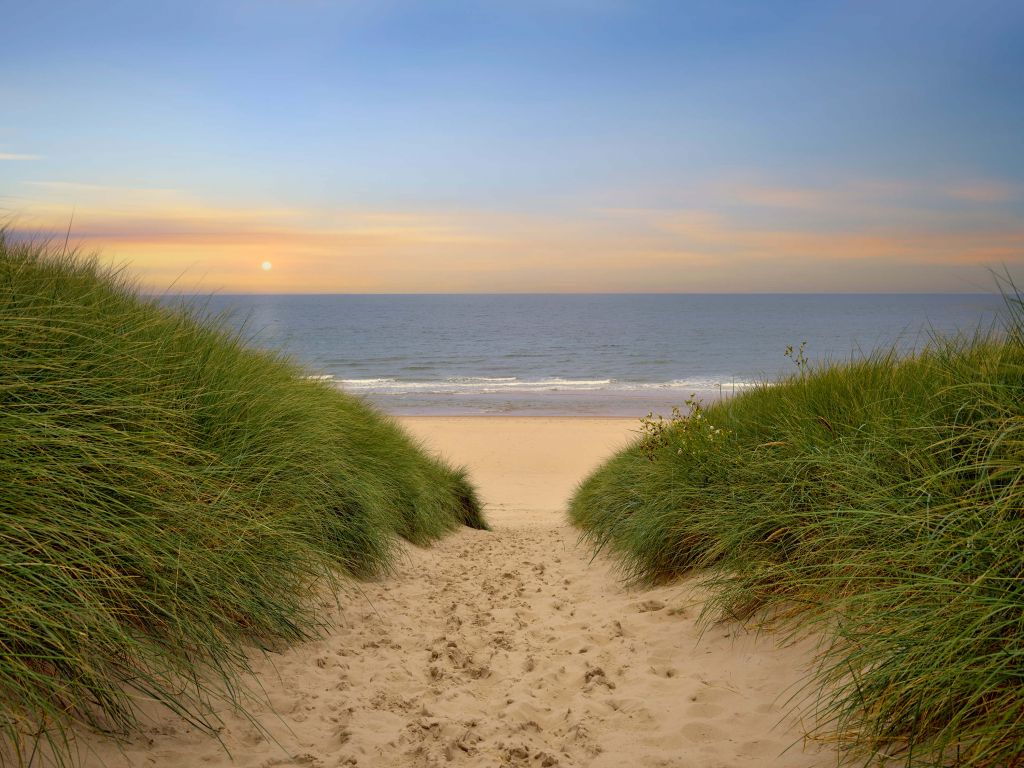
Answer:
[{"xmin": 186, "ymin": 294, "xmax": 1002, "ymax": 416}]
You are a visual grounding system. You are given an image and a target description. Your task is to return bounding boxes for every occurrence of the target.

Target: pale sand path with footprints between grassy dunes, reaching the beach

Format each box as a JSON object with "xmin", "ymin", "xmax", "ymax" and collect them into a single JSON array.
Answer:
[{"xmin": 72, "ymin": 418, "xmax": 837, "ymax": 768}]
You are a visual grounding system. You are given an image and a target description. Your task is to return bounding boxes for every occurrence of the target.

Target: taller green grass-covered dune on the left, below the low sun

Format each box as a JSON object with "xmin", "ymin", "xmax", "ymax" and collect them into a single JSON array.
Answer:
[{"xmin": 0, "ymin": 233, "xmax": 485, "ymax": 764}]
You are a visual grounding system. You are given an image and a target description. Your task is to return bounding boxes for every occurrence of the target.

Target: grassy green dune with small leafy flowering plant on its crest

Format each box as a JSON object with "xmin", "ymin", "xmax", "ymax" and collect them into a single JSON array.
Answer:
[{"xmin": 570, "ymin": 291, "xmax": 1024, "ymax": 766}]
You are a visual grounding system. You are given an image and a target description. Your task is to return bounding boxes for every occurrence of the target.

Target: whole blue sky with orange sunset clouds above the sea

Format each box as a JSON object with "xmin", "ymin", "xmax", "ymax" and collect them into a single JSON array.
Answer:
[{"xmin": 0, "ymin": 0, "xmax": 1024, "ymax": 293}]
